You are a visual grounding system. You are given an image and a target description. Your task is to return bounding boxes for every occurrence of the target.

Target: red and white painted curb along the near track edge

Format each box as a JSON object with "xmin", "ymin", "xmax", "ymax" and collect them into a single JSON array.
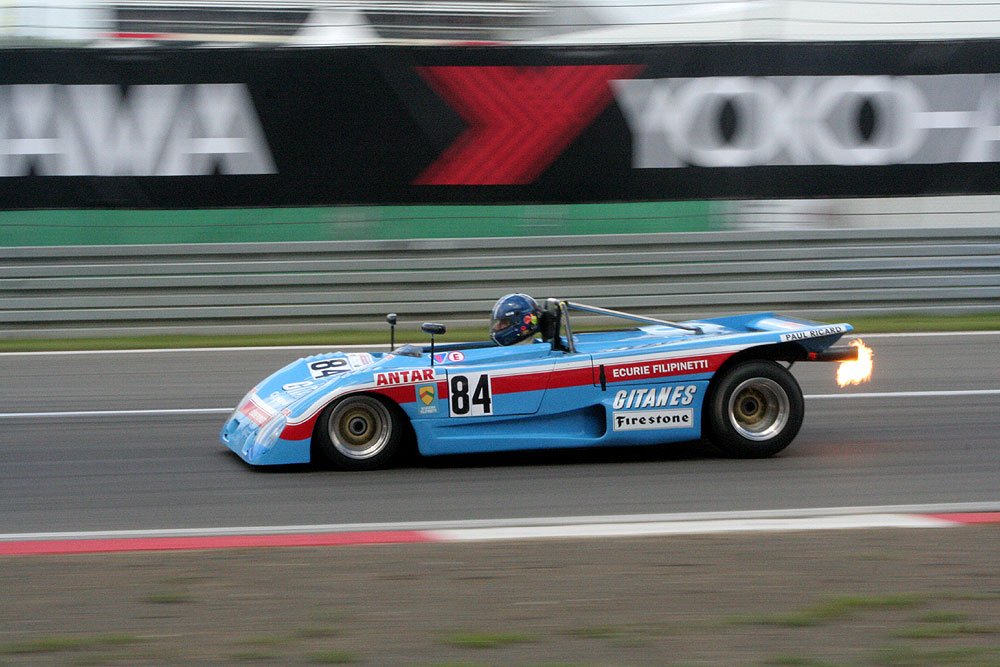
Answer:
[{"xmin": 0, "ymin": 503, "xmax": 1000, "ymax": 556}]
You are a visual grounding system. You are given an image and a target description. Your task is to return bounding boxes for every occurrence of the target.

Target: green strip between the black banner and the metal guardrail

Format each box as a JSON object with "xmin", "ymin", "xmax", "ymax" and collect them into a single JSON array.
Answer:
[{"xmin": 0, "ymin": 201, "xmax": 720, "ymax": 247}]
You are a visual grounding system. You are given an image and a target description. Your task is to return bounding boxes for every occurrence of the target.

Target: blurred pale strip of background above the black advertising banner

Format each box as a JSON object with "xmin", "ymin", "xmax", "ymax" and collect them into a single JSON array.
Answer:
[{"xmin": 0, "ymin": 0, "xmax": 1000, "ymax": 46}]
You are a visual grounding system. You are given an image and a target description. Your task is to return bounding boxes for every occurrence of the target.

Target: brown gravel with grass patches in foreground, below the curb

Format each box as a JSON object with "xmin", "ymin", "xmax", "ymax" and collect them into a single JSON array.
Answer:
[{"xmin": 0, "ymin": 526, "xmax": 1000, "ymax": 665}]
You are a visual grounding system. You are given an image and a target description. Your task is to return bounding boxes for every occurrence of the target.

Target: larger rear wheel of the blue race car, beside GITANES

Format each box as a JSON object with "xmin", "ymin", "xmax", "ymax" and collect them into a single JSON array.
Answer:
[{"xmin": 703, "ymin": 361, "xmax": 805, "ymax": 459}]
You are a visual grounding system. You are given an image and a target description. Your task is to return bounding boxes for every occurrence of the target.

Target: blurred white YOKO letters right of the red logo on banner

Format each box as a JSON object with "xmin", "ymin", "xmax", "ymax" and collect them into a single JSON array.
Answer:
[{"xmin": 612, "ymin": 73, "xmax": 1000, "ymax": 169}]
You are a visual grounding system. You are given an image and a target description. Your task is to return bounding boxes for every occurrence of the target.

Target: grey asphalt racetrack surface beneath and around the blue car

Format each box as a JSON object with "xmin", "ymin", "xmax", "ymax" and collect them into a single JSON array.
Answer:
[{"xmin": 0, "ymin": 334, "xmax": 1000, "ymax": 533}]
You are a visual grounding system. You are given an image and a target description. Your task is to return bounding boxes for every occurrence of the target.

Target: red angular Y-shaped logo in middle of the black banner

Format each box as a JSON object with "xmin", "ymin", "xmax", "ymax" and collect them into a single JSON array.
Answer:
[{"xmin": 414, "ymin": 65, "xmax": 642, "ymax": 185}]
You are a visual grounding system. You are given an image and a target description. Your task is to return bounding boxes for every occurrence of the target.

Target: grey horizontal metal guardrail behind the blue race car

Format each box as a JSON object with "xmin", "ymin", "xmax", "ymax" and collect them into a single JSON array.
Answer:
[{"xmin": 0, "ymin": 227, "xmax": 1000, "ymax": 339}]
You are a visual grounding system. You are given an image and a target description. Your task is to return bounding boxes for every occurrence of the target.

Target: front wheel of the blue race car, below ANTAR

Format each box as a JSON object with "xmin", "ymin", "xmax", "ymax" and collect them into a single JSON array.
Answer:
[{"xmin": 315, "ymin": 394, "xmax": 406, "ymax": 470}]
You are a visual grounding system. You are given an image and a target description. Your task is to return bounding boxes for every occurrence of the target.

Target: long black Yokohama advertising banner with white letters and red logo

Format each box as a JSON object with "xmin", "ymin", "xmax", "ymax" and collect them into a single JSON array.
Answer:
[{"xmin": 0, "ymin": 40, "xmax": 1000, "ymax": 210}]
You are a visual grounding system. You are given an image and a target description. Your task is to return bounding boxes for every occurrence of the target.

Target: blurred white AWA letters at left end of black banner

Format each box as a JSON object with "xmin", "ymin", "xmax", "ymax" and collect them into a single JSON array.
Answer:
[{"xmin": 0, "ymin": 83, "xmax": 277, "ymax": 177}]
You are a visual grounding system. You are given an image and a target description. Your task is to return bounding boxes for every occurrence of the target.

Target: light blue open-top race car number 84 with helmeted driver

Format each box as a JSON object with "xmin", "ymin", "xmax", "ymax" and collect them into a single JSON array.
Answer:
[{"xmin": 221, "ymin": 294, "xmax": 858, "ymax": 470}]
